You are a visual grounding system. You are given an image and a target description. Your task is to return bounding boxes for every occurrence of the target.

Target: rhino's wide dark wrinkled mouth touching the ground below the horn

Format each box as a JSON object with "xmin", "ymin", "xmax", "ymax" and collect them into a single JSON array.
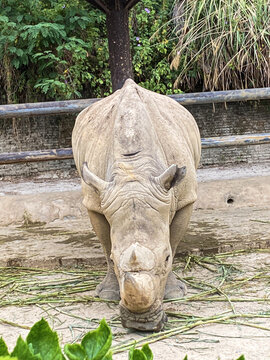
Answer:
[{"xmin": 120, "ymin": 304, "xmax": 167, "ymax": 331}]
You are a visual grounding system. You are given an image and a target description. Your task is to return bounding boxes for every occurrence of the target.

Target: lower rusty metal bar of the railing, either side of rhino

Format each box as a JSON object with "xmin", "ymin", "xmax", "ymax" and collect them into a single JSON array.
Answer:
[{"xmin": 0, "ymin": 133, "xmax": 270, "ymax": 165}]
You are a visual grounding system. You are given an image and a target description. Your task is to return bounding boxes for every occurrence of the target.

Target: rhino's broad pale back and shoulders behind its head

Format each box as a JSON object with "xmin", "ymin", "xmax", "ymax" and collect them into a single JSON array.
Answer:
[{"xmin": 72, "ymin": 80, "xmax": 200, "ymax": 212}]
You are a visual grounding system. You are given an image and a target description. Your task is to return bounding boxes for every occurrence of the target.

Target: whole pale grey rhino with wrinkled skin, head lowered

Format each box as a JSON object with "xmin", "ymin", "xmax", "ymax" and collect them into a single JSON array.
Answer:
[{"xmin": 72, "ymin": 80, "xmax": 200, "ymax": 330}]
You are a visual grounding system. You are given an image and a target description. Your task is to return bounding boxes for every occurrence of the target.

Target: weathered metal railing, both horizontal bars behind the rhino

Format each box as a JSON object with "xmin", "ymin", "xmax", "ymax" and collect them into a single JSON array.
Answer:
[{"xmin": 0, "ymin": 88, "xmax": 270, "ymax": 165}]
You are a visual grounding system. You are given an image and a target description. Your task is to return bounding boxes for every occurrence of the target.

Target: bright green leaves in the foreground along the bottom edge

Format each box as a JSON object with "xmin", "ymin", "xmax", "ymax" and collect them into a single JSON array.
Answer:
[{"xmin": 0, "ymin": 319, "xmax": 245, "ymax": 360}]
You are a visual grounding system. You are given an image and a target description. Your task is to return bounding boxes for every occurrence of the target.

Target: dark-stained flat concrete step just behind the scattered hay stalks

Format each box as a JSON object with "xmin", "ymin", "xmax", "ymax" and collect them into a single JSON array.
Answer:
[{"xmin": 0, "ymin": 207, "xmax": 270, "ymax": 268}]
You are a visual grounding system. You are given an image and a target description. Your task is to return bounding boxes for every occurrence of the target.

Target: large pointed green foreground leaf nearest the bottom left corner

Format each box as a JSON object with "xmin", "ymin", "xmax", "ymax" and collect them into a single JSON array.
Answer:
[{"xmin": 26, "ymin": 318, "xmax": 63, "ymax": 360}]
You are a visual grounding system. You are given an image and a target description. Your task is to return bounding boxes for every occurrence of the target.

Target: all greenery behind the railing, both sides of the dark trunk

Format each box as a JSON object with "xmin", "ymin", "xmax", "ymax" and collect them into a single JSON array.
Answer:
[{"xmin": 0, "ymin": 0, "xmax": 270, "ymax": 103}]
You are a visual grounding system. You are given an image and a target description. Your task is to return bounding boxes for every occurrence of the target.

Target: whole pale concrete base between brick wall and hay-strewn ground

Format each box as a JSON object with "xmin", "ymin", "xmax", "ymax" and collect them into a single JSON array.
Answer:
[{"xmin": 0, "ymin": 163, "xmax": 270, "ymax": 267}]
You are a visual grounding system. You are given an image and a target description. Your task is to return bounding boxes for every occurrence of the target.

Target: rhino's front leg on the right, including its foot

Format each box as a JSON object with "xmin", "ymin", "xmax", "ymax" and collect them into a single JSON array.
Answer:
[{"xmin": 164, "ymin": 204, "xmax": 193, "ymax": 299}]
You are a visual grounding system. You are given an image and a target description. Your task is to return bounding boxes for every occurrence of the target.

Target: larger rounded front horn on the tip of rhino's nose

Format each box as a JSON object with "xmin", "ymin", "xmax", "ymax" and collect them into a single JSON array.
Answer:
[{"xmin": 121, "ymin": 272, "xmax": 156, "ymax": 312}]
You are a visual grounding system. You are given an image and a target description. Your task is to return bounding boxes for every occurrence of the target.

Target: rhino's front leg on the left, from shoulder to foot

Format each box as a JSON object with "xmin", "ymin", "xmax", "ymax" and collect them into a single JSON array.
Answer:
[{"xmin": 88, "ymin": 210, "xmax": 120, "ymax": 300}]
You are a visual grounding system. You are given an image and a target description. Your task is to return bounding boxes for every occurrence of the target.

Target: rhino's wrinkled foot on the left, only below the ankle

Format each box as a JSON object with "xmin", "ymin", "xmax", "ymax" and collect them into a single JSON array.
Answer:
[{"xmin": 96, "ymin": 271, "xmax": 120, "ymax": 301}]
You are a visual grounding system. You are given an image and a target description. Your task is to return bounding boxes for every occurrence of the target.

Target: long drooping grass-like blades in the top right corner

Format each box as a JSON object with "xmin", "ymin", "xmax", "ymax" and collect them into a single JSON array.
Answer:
[{"xmin": 172, "ymin": 0, "xmax": 270, "ymax": 90}]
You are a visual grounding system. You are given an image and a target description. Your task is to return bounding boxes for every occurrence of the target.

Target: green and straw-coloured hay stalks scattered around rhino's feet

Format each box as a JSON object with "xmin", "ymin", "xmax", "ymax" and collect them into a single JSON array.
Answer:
[{"xmin": 0, "ymin": 249, "xmax": 270, "ymax": 353}]
